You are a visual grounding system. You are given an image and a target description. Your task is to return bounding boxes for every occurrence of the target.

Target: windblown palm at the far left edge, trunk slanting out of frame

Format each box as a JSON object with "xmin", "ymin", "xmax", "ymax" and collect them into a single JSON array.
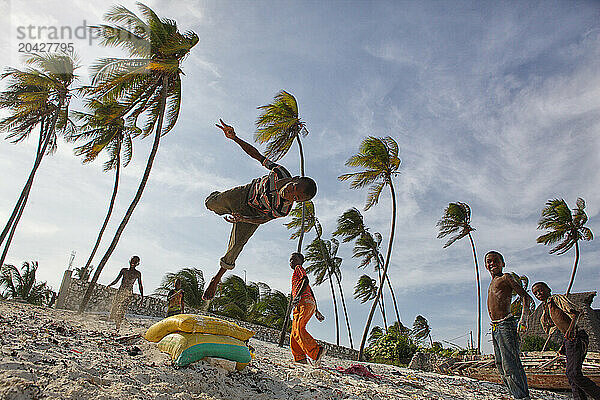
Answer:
[{"xmin": 0, "ymin": 53, "xmax": 77, "ymax": 266}]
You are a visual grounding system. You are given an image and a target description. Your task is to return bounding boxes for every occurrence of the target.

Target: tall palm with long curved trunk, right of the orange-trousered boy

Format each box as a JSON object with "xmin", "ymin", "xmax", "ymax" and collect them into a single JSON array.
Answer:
[{"xmin": 338, "ymin": 136, "xmax": 400, "ymax": 360}]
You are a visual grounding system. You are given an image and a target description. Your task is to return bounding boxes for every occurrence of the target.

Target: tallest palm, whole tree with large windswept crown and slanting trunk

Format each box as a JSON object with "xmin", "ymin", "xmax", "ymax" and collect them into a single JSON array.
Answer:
[{"xmin": 79, "ymin": 3, "xmax": 199, "ymax": 312}]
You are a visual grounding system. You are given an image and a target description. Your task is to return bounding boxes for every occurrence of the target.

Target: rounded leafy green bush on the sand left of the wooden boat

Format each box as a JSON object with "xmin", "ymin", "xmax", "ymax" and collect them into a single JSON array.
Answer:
[{"xmin": 366, "ymin": 330, "xmax": 418, "ymax": 366}]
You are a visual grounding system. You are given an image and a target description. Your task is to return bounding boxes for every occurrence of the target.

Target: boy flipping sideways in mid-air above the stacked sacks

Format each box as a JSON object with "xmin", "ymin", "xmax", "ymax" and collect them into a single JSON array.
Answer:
[{"xmin": 203, "ymin": 119, "xmax": 317, "ymax": 300}]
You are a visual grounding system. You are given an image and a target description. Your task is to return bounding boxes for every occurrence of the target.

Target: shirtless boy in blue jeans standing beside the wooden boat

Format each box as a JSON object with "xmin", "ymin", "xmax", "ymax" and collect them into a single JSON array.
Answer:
[{"xmin": 485, "ymin": 251, "xmax": 534, "ymax": 399}]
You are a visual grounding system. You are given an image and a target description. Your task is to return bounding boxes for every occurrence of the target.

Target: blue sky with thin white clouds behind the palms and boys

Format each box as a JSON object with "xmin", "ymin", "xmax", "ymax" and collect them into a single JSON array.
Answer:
[{"xmin": 0, "ymin": 0, "xmax": 600, "ymax": 353}]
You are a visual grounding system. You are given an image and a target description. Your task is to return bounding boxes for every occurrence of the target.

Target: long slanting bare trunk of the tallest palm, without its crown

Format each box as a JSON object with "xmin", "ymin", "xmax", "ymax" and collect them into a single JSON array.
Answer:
[{"xmin": 79, "ymin": 77, "xmax": 169, "ymax": 313}]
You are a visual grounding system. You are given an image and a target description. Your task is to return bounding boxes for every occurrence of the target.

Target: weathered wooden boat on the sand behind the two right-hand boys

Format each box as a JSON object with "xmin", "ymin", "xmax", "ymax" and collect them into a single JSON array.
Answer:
[{"xmin": 446, "ymin": 351, "xmax": 600, "ymax": 390}]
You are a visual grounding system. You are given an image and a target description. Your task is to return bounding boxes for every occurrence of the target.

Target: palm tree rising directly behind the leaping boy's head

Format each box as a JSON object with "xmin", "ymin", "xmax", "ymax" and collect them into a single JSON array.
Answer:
[{"xmin": 254, "ymin": 90, "xmax": 308, "ymax": 347}]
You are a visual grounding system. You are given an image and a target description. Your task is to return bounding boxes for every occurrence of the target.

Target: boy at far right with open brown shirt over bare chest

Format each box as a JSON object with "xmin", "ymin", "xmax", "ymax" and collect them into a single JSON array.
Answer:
[{"xmin": 531, "ymin": 282, "xmax": 600, "ymax": 400}]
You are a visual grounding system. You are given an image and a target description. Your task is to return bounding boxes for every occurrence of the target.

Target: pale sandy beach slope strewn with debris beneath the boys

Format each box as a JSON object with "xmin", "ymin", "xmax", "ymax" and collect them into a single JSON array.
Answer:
[{"xmin": 0, "ymin": 301, "xmax": 571, "ymax": 400}]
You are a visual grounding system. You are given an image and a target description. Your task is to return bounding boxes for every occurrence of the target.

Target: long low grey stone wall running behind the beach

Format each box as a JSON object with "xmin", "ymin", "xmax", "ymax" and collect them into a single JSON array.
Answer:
[{"xmin": 58, "ymin": 274, "xmax": 358, "ymax": 360}]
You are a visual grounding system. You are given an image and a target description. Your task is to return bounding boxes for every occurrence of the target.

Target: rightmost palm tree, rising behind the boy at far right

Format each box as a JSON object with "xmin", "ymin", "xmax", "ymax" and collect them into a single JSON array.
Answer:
[{"xmin": 537, "ymin": 197, "xmax": 594, "ymax": 295}]
